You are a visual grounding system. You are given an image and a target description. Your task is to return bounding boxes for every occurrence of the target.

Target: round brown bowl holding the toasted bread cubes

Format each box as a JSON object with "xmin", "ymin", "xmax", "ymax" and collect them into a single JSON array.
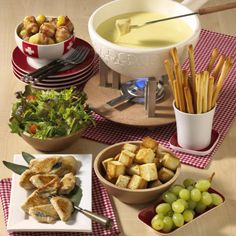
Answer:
[{"xmin": 94, "ymin": 141, "xmax": 181, "ymax": 204}]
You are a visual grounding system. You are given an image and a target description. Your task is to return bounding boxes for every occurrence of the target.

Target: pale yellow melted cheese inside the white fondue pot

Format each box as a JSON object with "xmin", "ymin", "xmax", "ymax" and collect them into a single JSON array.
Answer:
[{"xmin": 96, "ymin": 12, "xmax": 192, "ymax": 48}]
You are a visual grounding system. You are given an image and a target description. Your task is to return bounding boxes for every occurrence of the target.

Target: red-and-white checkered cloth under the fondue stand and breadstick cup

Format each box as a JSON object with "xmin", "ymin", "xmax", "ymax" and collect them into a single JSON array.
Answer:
[{"xmin": 83, "ymin": 30, "xmax": 236, "ymax": 169}]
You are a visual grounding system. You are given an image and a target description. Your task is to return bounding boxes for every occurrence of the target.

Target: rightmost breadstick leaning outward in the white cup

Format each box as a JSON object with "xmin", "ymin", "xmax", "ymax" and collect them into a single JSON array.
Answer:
[{"xmin": 212, "ymin": 57, "xmax": 233, "ymax": 107}]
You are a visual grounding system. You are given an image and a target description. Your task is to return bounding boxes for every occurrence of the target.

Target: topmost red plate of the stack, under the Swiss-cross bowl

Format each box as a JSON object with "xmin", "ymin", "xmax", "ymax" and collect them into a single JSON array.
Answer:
[{"xmin": 12, "ymin": 38, "xmax": 95, "ymax": 78}]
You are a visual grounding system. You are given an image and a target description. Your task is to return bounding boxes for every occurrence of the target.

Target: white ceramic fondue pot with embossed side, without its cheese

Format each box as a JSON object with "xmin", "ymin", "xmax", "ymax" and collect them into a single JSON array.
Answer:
[{"xmin": 88, "ymin": 0, "xmax": 207, "ymax": 78}]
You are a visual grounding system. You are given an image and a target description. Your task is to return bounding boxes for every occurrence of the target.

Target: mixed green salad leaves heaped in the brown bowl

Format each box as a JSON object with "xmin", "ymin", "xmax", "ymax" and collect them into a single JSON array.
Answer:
[{"xmin": 9, "ymin": 85, "xmax": 95, "ymax": 139}]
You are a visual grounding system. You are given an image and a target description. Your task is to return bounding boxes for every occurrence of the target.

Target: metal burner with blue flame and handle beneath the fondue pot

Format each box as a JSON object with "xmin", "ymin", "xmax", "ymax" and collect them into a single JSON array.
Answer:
[{"xmin": 107, "ymin": 78, "xmax": 165, "ymax": 107}]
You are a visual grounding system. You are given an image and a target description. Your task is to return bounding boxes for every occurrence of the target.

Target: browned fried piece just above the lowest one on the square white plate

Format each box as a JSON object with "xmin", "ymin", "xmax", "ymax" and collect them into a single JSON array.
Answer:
[{"xmin": 21, "ymin": 190, "xmax": 49, "ymax": 213}]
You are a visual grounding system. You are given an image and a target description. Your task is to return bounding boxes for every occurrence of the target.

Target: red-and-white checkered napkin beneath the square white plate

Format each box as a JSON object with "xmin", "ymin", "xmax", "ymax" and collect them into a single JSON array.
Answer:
[{"xmin": 0, "ymin": 173, "xmax": 120, "ymax": 236}]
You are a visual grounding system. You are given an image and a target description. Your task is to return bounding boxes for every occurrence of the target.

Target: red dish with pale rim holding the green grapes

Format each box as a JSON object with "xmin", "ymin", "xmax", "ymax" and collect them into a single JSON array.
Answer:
[{"xmin": 138, "ymin": 188, "xmax": 225, "ymax": 235}]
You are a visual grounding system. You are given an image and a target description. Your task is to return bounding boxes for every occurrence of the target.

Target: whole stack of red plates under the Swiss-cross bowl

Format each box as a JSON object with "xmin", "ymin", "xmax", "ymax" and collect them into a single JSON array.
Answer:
[{"xmin": 12, "ymin": 38, "xmax": 98, "ymax": 89}]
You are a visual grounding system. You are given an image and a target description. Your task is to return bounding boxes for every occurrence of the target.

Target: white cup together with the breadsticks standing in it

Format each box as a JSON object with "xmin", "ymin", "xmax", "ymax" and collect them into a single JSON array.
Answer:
[{"xmin": 164, "ymin": 45, "xmax": 233, "ymax": 150}]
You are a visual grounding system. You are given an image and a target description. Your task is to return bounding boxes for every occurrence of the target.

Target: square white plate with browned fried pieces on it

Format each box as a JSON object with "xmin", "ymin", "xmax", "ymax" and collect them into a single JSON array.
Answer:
[{"xmin": 7, "ymin": 154, "xmax": 92, "ymax": 232}]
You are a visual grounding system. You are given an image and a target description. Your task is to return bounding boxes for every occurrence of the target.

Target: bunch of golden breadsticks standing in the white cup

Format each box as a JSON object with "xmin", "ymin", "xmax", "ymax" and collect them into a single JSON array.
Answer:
[{"xmin": 164, "ymin": 45, "xmax": 233, "ymax": 114}]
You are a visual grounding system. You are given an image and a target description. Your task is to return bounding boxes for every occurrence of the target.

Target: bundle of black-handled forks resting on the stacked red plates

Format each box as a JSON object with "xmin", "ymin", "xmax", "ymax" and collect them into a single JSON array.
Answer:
[{"xmin": 23, "ymin": 47, "xmax": 90, "ymax": 82}]
